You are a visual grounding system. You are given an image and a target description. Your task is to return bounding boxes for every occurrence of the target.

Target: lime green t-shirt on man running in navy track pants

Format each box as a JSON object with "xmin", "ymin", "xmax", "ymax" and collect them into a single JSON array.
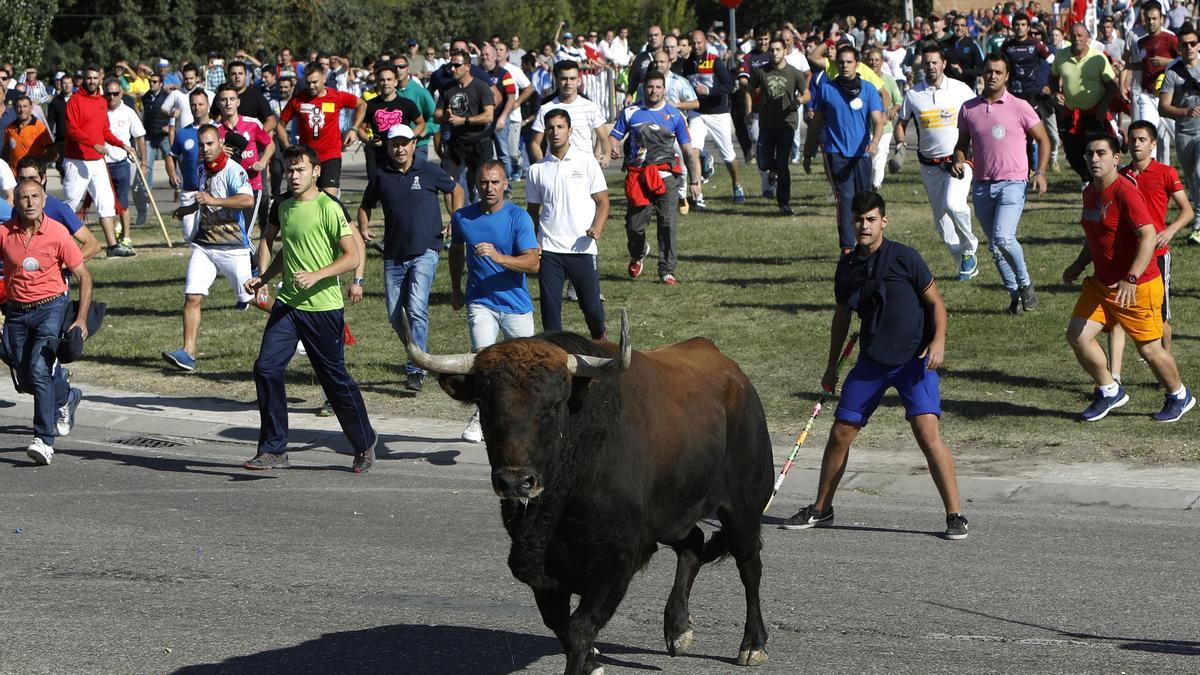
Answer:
[{"xmin": 278, "ymin": 192, "xmax": 350, "ymax": 312}]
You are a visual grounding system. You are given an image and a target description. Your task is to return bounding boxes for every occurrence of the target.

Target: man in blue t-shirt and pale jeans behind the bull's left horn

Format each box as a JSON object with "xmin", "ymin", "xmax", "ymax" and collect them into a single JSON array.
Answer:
[{"xmin": 450, "ymin": 160, "xmax": 541, "ymax": 443}]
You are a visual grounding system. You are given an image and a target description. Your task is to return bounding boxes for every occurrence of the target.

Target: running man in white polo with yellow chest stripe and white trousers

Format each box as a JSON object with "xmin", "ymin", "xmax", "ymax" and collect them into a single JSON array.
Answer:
[{"xmin": 893, "ymin": 41, "xmax": 979, "ymax": 281}]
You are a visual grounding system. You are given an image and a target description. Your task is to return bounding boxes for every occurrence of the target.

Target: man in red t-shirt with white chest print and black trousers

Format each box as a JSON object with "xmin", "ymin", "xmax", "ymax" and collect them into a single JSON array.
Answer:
[{"xmin": 275, "ymin": 61, "xmax": 359, "ymax": 197}]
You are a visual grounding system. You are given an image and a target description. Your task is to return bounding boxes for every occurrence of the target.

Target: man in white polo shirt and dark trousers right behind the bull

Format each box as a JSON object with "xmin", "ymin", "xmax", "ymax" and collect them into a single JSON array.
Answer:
[{"xmin": 526, "ymin": 108, "xmax": 608, "ymax": 340}]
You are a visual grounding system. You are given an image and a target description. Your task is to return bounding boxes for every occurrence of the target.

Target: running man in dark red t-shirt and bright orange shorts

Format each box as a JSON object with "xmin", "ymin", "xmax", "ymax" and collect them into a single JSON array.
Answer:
[{"xmin": 1062, "ymin": 135, "xmax": 1196, "ymax": 422}]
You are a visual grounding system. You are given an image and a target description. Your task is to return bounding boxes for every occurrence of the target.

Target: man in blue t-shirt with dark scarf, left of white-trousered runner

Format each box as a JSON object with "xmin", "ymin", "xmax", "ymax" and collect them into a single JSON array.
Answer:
[{"xmin": 804, "ymin": 44, "xmax": 883, "ymax": 255}]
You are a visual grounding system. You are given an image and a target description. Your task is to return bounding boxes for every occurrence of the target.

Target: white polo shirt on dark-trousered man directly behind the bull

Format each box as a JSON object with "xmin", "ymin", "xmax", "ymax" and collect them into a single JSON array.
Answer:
[{"xmin": 526, "ymin": 141, "xmax": 608, "ymax": 255}]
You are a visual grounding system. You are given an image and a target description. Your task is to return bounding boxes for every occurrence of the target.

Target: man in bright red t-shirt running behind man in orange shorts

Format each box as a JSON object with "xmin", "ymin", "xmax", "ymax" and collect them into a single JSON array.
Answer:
[{"xmin": 1109, "ymin": 120, "xmax": 1195, "ymax": 382}]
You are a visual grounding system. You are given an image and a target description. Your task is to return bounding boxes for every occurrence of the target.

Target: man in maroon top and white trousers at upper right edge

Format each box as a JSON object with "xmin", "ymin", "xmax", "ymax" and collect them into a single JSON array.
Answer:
[{"xmin": 1121, "ymin": 0, "xmax": 1180, "ymax": 165}]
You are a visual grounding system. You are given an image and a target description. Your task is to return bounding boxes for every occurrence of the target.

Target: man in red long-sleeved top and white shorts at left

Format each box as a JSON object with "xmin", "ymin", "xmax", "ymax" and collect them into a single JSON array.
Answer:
[{"xmin": 62, "ymin": 66, "xmax": 136, "ymax": 257}]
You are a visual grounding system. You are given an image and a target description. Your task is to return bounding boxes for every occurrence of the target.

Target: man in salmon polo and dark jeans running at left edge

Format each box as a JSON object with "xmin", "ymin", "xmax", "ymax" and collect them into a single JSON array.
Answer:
[{"xmin": 0, "ymin": 178, "xmax": 91, "ymax": 465}]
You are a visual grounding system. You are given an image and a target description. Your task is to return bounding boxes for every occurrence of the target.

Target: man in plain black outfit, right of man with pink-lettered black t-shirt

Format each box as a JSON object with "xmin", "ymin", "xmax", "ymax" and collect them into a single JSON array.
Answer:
[{"xmin": 433, "ymin": 49, "xmax": 496, "ymax": 201}]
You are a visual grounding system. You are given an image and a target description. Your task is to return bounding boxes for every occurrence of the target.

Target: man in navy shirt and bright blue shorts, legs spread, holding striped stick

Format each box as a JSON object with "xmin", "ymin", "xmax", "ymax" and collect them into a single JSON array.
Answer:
[{"xmin": 781, "ymin": 191, "xmax": 967, "ymax": 539}]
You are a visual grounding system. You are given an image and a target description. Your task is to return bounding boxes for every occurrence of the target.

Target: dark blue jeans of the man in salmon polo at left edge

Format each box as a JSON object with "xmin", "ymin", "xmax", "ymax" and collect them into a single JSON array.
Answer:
[{"xmin": 0, "ymin": 295, "xmax": 71, "ymax": 446}]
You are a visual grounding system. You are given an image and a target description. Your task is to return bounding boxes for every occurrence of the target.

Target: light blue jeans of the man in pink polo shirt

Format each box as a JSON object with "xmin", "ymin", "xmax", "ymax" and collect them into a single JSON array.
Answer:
[{"xmin": 971, "ymin": 180, "xmax": 1030, "ymax": 293}]
